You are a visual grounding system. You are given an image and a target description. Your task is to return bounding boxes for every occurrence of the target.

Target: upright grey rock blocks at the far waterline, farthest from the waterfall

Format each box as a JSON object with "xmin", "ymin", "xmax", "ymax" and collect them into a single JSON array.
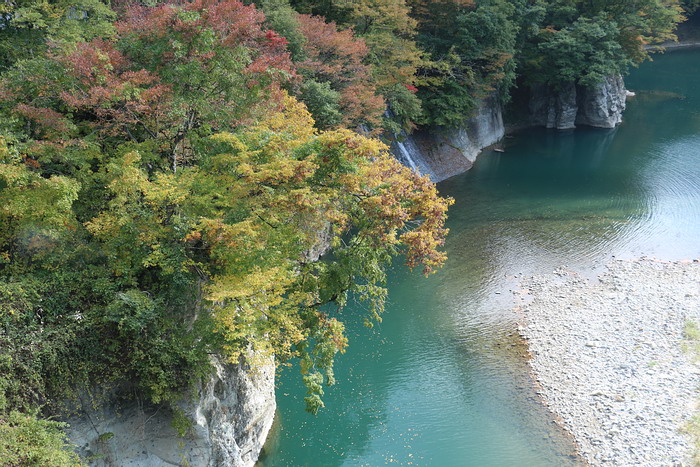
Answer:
[{"xmin": 530, "ymin": 75, "xmax": 627, "ymax": 130}]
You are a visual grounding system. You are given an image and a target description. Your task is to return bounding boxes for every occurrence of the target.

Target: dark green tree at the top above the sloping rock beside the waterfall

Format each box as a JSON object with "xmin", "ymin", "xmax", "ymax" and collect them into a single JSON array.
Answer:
[{"xmin": 418, "ymin": 0, "xmax": 527, "ymax": 127}]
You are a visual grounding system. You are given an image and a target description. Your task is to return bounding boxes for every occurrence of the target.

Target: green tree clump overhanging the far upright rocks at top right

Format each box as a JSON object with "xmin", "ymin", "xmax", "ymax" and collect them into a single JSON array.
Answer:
[{"xmin": 523, "ymin": 0, "xmax": 683, "ymax": 87}]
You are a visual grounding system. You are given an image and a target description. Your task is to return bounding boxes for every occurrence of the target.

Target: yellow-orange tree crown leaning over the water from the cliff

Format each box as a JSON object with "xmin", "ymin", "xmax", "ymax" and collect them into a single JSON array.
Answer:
[{"xmin": 189, "ymin": 102, "xmax": 450, "ymax": 372}]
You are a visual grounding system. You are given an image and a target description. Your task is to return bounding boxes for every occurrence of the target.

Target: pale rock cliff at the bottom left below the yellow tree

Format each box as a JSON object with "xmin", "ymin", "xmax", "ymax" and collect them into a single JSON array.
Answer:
[{"xmin": 67, "ymin": 359, "xmax": 276, "ymax": 467}]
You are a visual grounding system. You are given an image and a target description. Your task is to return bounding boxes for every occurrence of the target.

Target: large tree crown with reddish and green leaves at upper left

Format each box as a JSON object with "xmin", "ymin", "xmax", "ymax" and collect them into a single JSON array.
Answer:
[{"xmin": 32, "ymin": 0, "xmax": 296, "ymax": 146}]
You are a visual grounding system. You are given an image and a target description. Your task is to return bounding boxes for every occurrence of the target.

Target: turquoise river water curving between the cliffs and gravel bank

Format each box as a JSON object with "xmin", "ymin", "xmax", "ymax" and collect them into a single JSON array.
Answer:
[{"xmin": 260, "ymin": 51, "xmax": 700, "ymax": 467}]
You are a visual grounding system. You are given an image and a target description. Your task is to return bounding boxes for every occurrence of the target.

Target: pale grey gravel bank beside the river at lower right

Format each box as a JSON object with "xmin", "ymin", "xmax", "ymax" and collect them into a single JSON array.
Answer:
[{"xmin": 520, "ymin": 259, "xmax": 700, "ymax": 466}]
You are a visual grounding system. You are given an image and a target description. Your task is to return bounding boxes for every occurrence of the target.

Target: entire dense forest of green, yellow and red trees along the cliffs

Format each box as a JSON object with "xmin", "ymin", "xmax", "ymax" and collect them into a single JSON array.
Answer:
[{"xmin": 0, "ymin": 0, "xmax": 697, "ymax": 465}]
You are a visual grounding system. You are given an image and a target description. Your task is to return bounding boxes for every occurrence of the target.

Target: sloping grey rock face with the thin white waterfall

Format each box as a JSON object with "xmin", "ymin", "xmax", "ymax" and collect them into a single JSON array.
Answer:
[{"xmin": 392, "ymin": 99, "xmax": 505, "ymax": 182}]
